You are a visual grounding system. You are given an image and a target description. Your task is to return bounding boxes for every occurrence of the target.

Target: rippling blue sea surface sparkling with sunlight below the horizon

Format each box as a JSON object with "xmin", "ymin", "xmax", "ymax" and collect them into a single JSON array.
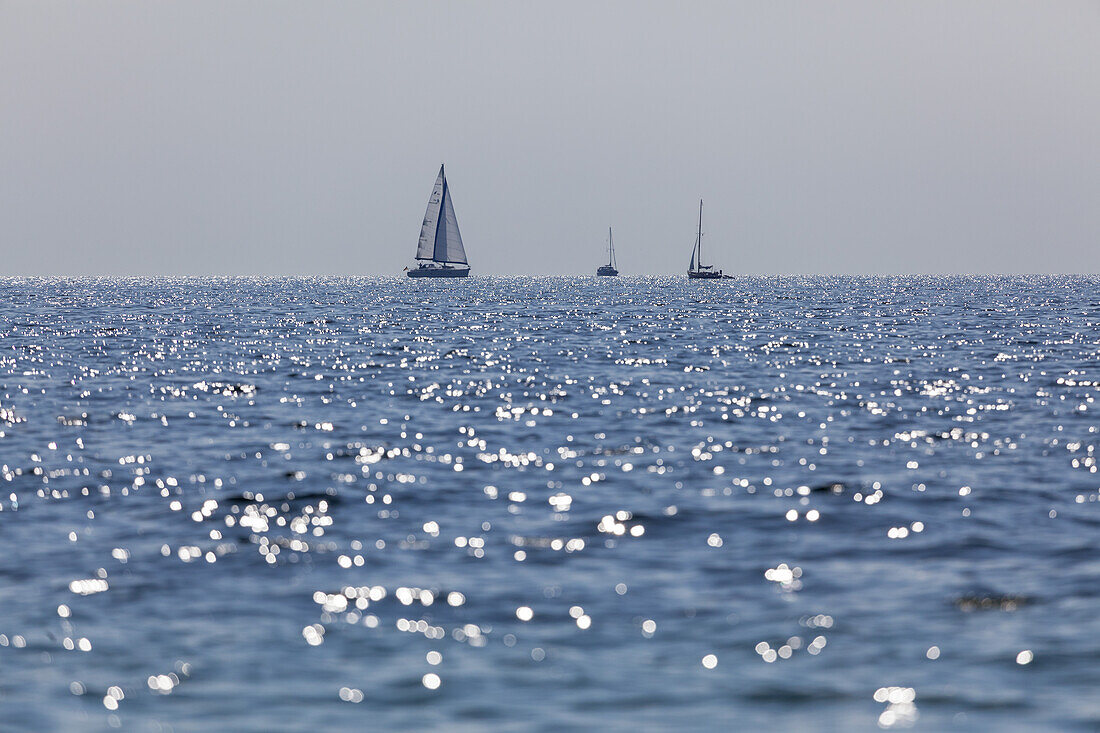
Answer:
[{"xmin": 0, "ymin": 277, "xmax": 1100, "ymax": 732}]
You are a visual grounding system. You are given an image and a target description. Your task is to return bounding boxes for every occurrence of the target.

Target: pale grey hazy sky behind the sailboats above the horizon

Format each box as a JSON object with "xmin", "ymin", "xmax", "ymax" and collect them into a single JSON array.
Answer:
[{"xmin": 0, "ymin": 0, "xmax": 1100, "ymax": 274}]
